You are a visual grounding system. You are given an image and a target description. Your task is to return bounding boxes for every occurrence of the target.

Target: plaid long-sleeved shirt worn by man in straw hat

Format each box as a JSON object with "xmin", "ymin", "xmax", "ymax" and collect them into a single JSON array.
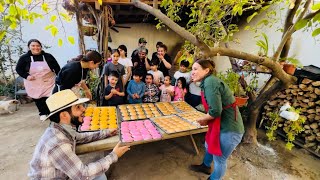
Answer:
[{"xmin": 28, "ymin": 122, "xmax": 118, "ymax": 179}]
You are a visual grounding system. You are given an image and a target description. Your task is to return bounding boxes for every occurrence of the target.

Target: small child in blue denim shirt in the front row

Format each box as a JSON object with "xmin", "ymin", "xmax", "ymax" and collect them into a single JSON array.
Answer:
[{"xmin": 127, "ymin": 71, "xmax": 145, "ymax": 104}]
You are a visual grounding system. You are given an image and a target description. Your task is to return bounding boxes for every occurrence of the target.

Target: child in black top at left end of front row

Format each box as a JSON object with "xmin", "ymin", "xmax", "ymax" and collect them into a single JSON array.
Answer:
[{"xmin": 102, "ymin": 71, "xmax": 124, "ymax": 106}]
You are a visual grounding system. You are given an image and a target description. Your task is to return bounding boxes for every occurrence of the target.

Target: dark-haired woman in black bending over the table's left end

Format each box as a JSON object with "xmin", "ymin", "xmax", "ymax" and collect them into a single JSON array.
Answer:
[{"xmin": 53, "ymin": 51, "xmax": 102, "ymax": 99}]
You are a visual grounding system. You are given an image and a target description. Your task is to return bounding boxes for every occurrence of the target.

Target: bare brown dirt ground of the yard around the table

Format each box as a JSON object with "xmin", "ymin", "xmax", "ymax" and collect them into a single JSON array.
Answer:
[{"xmin": 0, "ymin": 104, "xmax": 320, "ymax": 180}]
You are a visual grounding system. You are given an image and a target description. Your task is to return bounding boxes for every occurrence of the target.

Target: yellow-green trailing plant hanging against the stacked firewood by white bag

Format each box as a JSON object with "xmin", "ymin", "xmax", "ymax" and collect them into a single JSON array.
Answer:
[{"xmin": 266, "ymin": 107, "xmax": 306, "ymax": 150}]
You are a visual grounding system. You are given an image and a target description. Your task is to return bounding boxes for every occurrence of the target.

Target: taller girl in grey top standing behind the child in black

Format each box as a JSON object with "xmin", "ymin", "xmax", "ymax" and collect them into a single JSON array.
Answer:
[{"xmin": 103, "ymin": 49, "xmax": 125, "ymax": 88}]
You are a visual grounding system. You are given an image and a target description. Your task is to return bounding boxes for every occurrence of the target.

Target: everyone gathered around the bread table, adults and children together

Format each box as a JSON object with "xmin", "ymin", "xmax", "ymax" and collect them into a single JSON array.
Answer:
[{"xmin": 16, "ymin": 38, "xmax": 244, "ymax": 179}]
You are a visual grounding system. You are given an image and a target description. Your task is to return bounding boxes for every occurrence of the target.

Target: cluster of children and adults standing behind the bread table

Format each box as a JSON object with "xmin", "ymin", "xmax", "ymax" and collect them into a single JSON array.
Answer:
[{"xmin": 101, "ymin": 38, "xmax": 201, "ymax": 107}]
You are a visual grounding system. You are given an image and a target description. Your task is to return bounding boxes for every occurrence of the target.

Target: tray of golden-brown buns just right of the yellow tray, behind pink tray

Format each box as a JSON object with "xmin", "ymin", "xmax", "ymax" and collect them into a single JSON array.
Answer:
[{"xmin": 118, "ymin": 103, "xmax": 161, "ymax": 121}]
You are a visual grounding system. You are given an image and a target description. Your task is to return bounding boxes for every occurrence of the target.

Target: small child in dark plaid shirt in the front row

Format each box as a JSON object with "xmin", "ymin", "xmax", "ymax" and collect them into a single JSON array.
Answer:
[{"xmin": 143, "ymin": 74, "xmax": 159, "ymax": 103}]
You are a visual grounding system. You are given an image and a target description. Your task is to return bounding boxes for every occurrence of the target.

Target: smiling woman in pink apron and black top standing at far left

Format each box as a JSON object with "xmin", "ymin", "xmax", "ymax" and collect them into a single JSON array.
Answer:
[{"xmin": 16, "ymin": 39, "xmax": 60, "ymax": 120}]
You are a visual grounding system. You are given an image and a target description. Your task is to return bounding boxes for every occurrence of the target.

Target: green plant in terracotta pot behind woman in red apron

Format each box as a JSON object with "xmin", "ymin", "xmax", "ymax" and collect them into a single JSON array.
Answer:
[{"xmin": 217, "ymin": 69, "xmax": 252, "ymax": 107}]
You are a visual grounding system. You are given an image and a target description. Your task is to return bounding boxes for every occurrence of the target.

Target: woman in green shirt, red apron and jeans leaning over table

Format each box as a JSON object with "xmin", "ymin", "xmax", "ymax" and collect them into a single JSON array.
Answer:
[{"xmin": 190, "ymin": 60, "xmax": 244, "ymax": 180}]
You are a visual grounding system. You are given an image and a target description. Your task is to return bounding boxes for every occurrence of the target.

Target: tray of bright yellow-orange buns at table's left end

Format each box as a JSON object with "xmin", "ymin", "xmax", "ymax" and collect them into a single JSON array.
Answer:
[{"xmin": 80, "ymin": 106, "xmax": 118, "ymax": 132}]
